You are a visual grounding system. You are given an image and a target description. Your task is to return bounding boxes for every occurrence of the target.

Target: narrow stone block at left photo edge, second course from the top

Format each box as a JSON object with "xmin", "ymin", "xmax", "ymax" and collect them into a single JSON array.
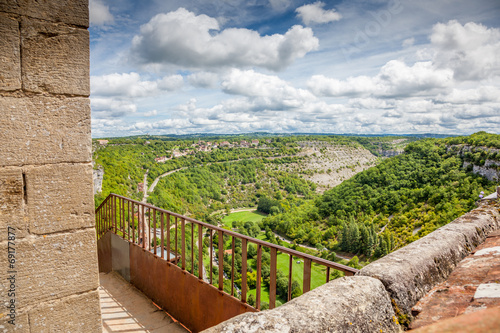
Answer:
[{"xmin": 0, "ymin": 14, "xmax": 21, "ymax": 91}]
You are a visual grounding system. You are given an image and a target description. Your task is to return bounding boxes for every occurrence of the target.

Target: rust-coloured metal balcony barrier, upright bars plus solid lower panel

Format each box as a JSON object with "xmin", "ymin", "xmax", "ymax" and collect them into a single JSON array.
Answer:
[{"xmin": 96, "ymin": 194, "xmax": 357, "ymax": 332}]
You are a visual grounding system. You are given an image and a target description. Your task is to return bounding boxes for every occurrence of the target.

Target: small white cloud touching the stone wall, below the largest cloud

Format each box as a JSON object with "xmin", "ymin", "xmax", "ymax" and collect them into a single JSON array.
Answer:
[{"xmin": 90, "ymin": 72, "xmax": 183, "ymax": 97}]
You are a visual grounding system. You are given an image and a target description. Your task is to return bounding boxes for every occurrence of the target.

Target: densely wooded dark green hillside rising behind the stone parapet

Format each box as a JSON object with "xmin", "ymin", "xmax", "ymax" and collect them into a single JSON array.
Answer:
[{"xmin": 263, "ymin": 133, "xmax": 500, "ymax": 258}]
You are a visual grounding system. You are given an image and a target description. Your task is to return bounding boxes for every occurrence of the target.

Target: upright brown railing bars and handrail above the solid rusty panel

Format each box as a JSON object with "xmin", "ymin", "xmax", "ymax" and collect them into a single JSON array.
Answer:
[{"xmin": 96, "ymin": 194, "xmax": 358, "ymax": 310}]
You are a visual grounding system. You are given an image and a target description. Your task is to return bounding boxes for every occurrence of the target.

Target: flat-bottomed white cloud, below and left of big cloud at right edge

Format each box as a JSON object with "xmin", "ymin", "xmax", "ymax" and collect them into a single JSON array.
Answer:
[{"xmin": 307, "ymin": 60, "xmax": 453, "ymax": 97}]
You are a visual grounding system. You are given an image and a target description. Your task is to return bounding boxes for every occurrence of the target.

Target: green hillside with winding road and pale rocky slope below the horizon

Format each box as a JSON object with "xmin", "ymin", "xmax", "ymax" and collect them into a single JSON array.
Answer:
[{"xmin": 93, "ymin": 135, "xmax": 392, "ymax": 215}]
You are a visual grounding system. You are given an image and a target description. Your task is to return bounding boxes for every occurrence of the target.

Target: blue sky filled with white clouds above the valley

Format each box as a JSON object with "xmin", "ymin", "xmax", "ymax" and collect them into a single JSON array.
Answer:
[{"xmin": 89, "ymin": 0, "xmax": 500, "ymax": 137}]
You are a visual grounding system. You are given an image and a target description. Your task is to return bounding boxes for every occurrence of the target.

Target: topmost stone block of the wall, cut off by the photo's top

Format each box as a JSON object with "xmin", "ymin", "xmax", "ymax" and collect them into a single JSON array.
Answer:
[{"xmin": 0, "ymin": 0, "xmax": 89, "ymax": 28}]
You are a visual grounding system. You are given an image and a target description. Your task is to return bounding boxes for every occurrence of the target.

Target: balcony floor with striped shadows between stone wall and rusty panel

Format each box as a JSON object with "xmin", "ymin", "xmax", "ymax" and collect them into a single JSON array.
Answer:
[{"xmin": 99, "ymin": 272, "xmax": 189, "ymax": 333}]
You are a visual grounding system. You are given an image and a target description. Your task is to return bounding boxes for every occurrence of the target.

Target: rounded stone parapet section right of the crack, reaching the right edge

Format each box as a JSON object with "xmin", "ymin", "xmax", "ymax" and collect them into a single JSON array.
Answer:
[{"xmin": 358, "ymin": 203, "xmax": 500, "ymax": 318}]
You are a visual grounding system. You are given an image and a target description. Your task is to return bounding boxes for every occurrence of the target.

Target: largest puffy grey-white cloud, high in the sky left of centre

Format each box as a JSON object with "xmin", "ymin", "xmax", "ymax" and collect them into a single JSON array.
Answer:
[{"xmin": 131, "ymin": 8, "xmax": 319, "ymax": 71}]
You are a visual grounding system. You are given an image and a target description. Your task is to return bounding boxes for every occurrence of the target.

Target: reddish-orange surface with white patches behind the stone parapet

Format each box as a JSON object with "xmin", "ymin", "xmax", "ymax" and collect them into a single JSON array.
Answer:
[{"xmin": 410, "ymin": 231, "xmax": 500, "ymax": 333}]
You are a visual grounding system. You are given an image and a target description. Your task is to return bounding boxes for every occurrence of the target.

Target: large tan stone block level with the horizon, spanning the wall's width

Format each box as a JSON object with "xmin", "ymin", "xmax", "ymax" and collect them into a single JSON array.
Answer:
[{"xmin": 0, "ymin": 96, "xmax": 92, "ymax": 166}]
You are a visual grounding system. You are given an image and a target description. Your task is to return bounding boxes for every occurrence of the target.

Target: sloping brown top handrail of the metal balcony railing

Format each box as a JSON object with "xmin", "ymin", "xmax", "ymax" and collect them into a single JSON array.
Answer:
[{"xmin": 105, "ymin": 193, "xmax": 359, "ymax": 275}]
